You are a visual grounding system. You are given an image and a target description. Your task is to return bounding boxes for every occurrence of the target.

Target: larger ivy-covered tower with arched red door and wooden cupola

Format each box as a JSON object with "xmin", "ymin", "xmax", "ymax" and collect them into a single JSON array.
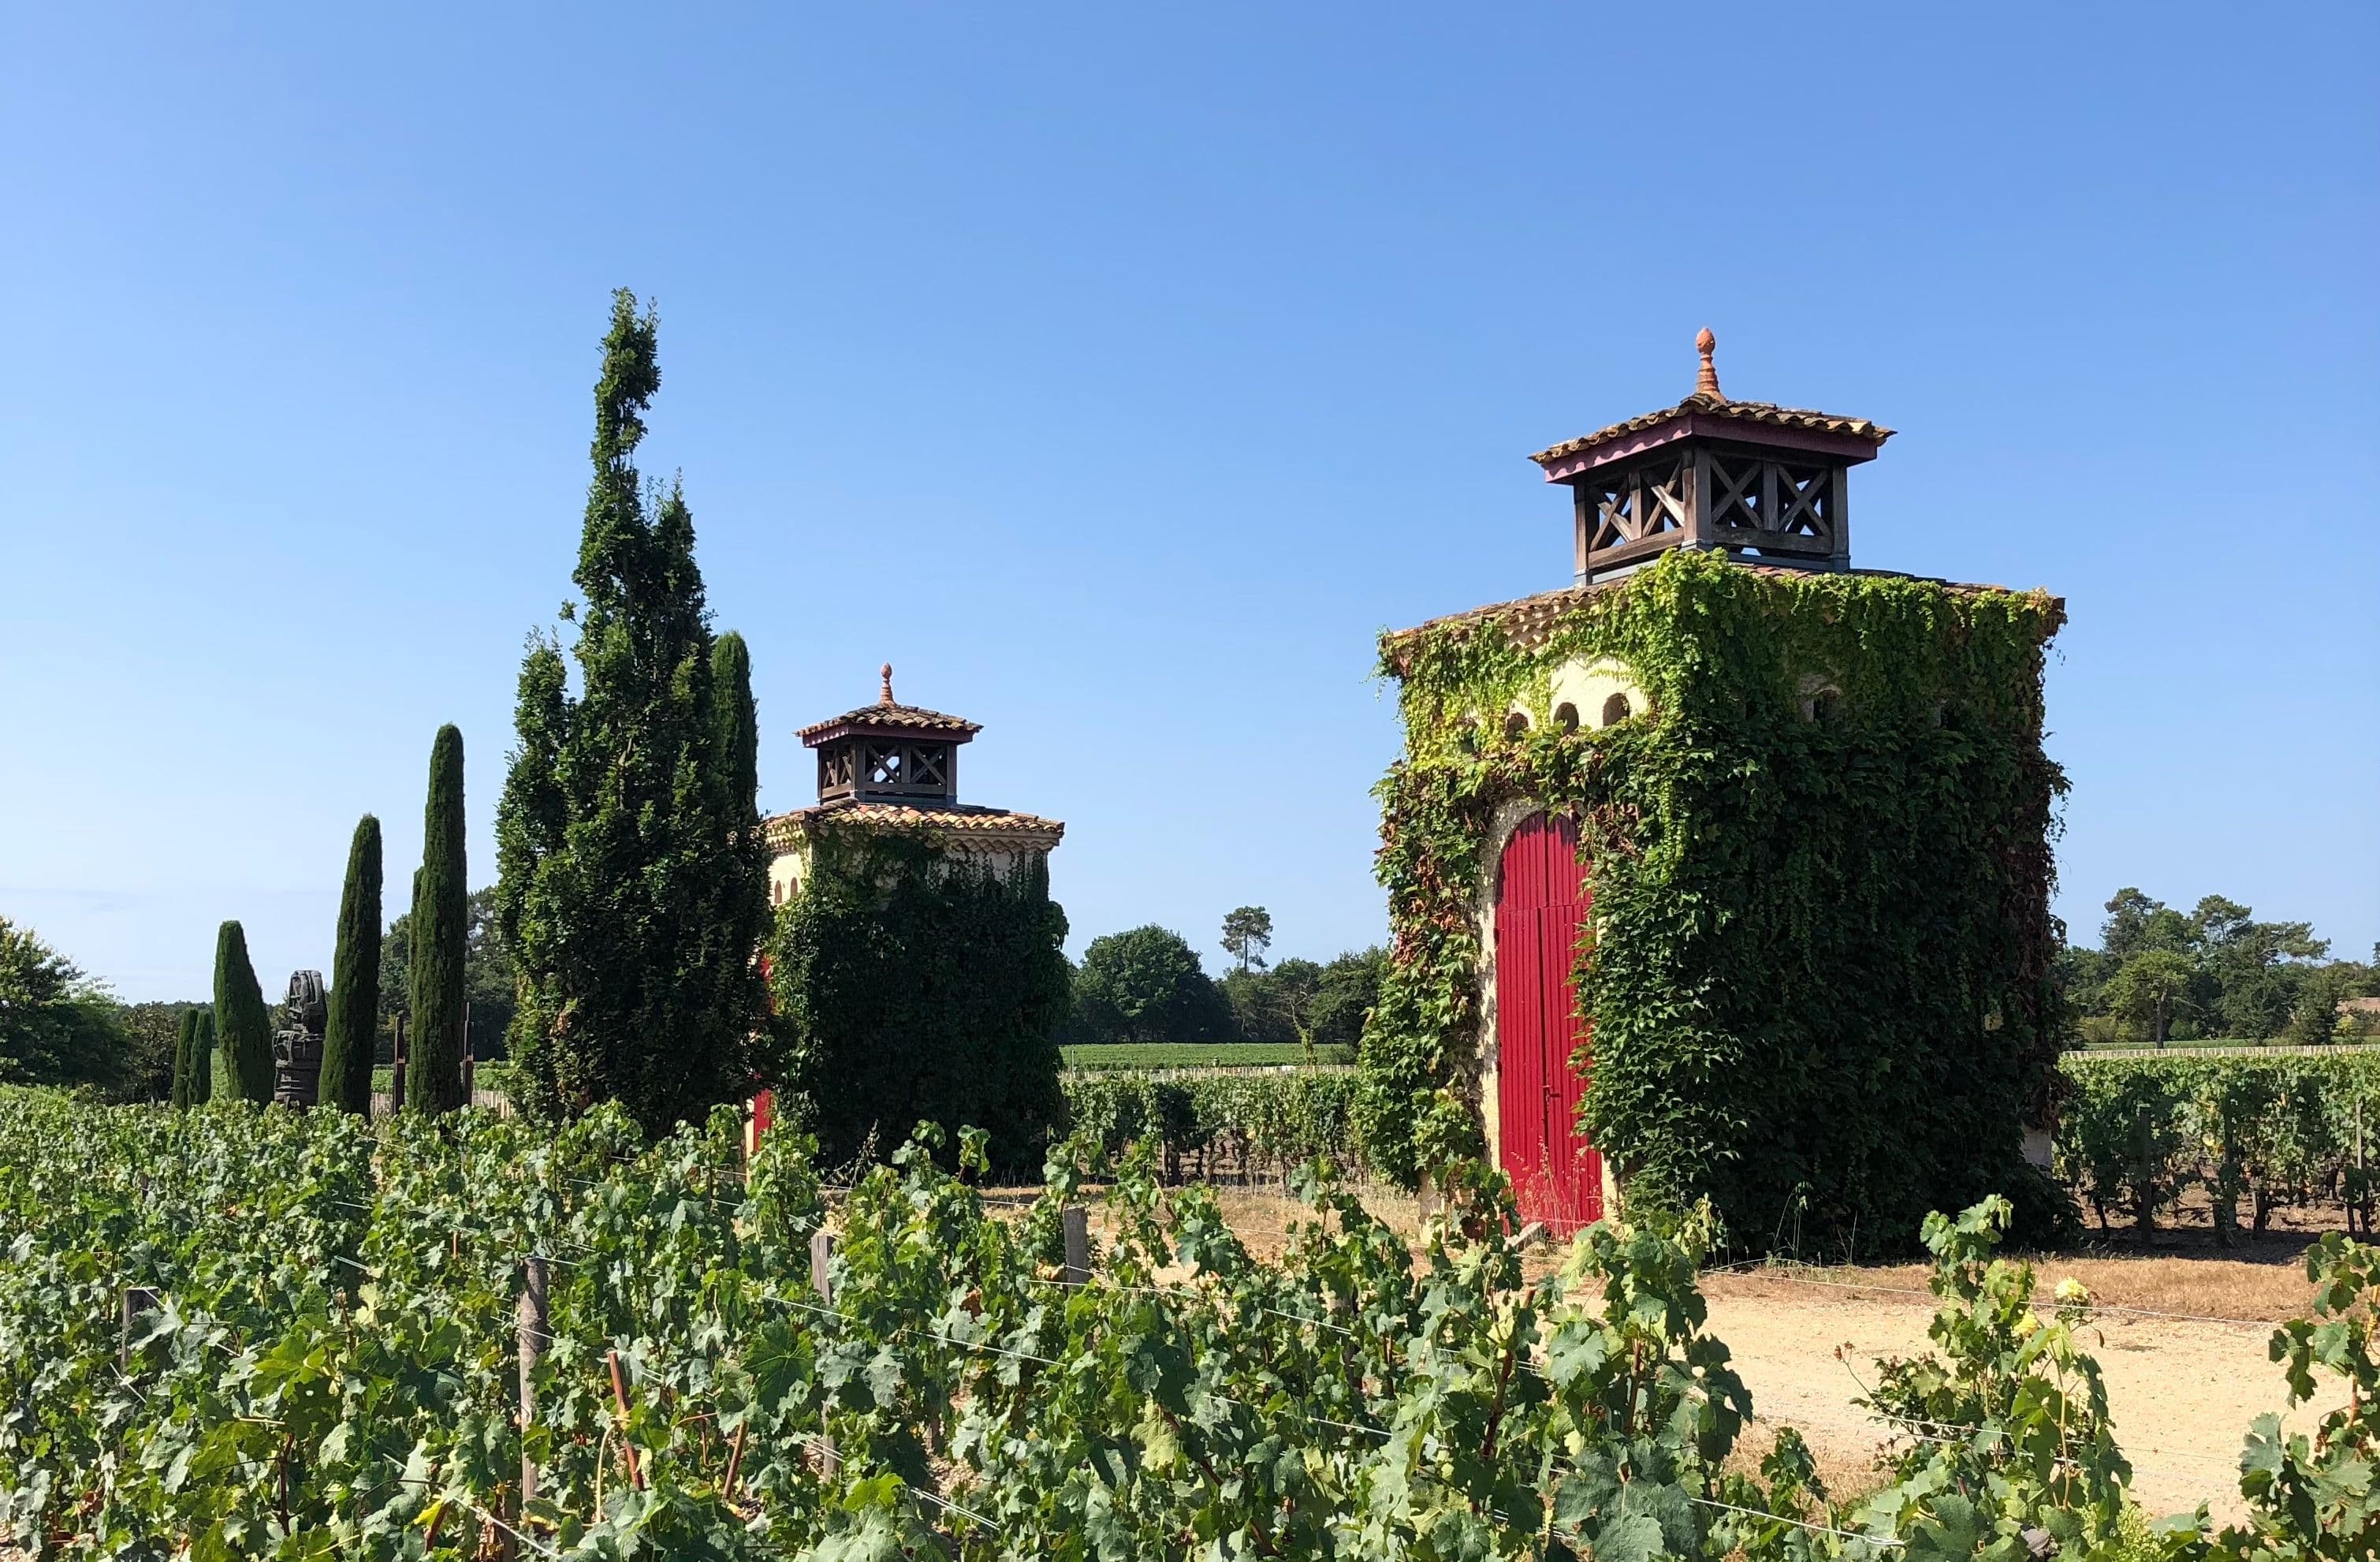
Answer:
[{"xmin": 1361, "ymin": 331, "xmax": 2063, "ymax": 1254}]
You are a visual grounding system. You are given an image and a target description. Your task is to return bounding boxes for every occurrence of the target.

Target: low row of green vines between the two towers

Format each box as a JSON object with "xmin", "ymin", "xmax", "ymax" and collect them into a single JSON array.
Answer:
[{"xmin": 1067, "ymin": 1069, "xmax": 1364, "ymax": 1179}]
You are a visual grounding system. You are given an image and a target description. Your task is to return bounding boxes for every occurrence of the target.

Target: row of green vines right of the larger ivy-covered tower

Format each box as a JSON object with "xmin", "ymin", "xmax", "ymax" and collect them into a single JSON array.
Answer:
[{"xmin": 2056, "ymin": 1050, "xmax": 2380, "ymax": 1240}]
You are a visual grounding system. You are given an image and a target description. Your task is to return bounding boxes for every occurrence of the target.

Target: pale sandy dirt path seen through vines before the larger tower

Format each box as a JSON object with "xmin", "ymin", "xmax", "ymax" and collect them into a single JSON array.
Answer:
[{"xmin": 1707, "ymin": 1262, "xmax": 2321, "ymax": 1519}]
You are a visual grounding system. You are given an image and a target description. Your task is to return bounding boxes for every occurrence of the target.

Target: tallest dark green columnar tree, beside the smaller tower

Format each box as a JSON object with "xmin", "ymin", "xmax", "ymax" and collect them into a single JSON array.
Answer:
[{"xmin": 497, "ymin": 290, "xmax": 769, "ymax": 1131}]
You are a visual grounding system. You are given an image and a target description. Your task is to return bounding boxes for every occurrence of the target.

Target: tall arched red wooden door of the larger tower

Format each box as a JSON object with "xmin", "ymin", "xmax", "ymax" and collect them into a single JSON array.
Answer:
[{"xmin": 1495, "ymin": 815, "xmax": 1604, "ymax": 1233}]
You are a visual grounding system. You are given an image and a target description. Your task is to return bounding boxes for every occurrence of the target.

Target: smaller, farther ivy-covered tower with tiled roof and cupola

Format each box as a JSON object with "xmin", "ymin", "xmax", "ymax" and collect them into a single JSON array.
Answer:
[{"xmin": 757, "ymin": 665, "xmax": 1069, "ymax": 1172}]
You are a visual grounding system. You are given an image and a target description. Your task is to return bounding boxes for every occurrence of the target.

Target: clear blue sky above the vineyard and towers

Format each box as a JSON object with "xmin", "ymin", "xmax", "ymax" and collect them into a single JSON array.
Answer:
[{"xmin": 0, "ymin": 5, "xmax": 2380, "ymax": 997}]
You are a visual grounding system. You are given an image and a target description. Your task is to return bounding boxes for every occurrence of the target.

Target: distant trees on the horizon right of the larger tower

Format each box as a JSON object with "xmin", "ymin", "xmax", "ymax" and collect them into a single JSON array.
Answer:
[{"xmin": 2058, "ymin": 888, "xmax": 2380, "ymax": 1048}]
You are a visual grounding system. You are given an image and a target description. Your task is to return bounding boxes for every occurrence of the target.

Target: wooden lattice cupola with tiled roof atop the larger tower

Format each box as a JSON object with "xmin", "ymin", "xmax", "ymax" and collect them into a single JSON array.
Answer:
[{"xmin": 1530, "ymin": 331, "xmax": 1892, "ymax": 586}]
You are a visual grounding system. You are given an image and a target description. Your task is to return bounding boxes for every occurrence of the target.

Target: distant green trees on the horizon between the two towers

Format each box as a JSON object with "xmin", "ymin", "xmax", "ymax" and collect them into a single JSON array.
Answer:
[{"xmin": 1063, "ymin": 905, "xmax": 1387, "ymax": 1048}]
